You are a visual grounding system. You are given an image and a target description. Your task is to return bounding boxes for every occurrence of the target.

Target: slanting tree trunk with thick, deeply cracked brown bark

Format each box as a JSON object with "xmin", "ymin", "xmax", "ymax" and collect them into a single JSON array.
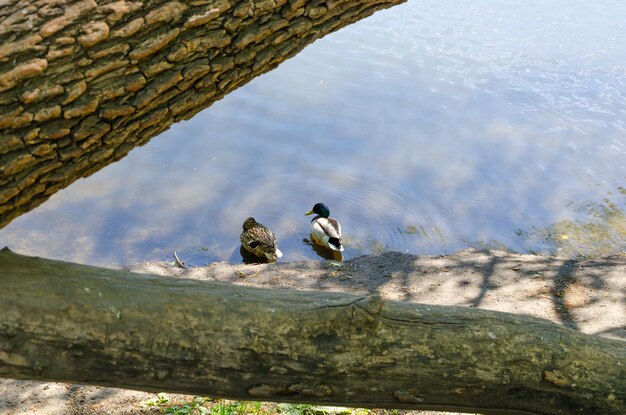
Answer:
[{"xmin": 0, "ymin": 0, "xmax": 406, "ymax": 227}]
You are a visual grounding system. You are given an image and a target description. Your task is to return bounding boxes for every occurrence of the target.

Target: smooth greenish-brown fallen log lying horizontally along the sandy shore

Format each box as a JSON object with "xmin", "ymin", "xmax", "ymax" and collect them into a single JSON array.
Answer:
[{"xmin": 0, "ymin": 249, "xmax": 626, "ymax": 415}]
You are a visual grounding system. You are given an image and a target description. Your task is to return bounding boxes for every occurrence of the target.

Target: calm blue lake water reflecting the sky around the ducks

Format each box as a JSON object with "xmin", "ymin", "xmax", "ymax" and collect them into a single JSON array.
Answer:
[{"xmin": 0, "ymin": 0, "xmax": 626, "ymax": 265}]
